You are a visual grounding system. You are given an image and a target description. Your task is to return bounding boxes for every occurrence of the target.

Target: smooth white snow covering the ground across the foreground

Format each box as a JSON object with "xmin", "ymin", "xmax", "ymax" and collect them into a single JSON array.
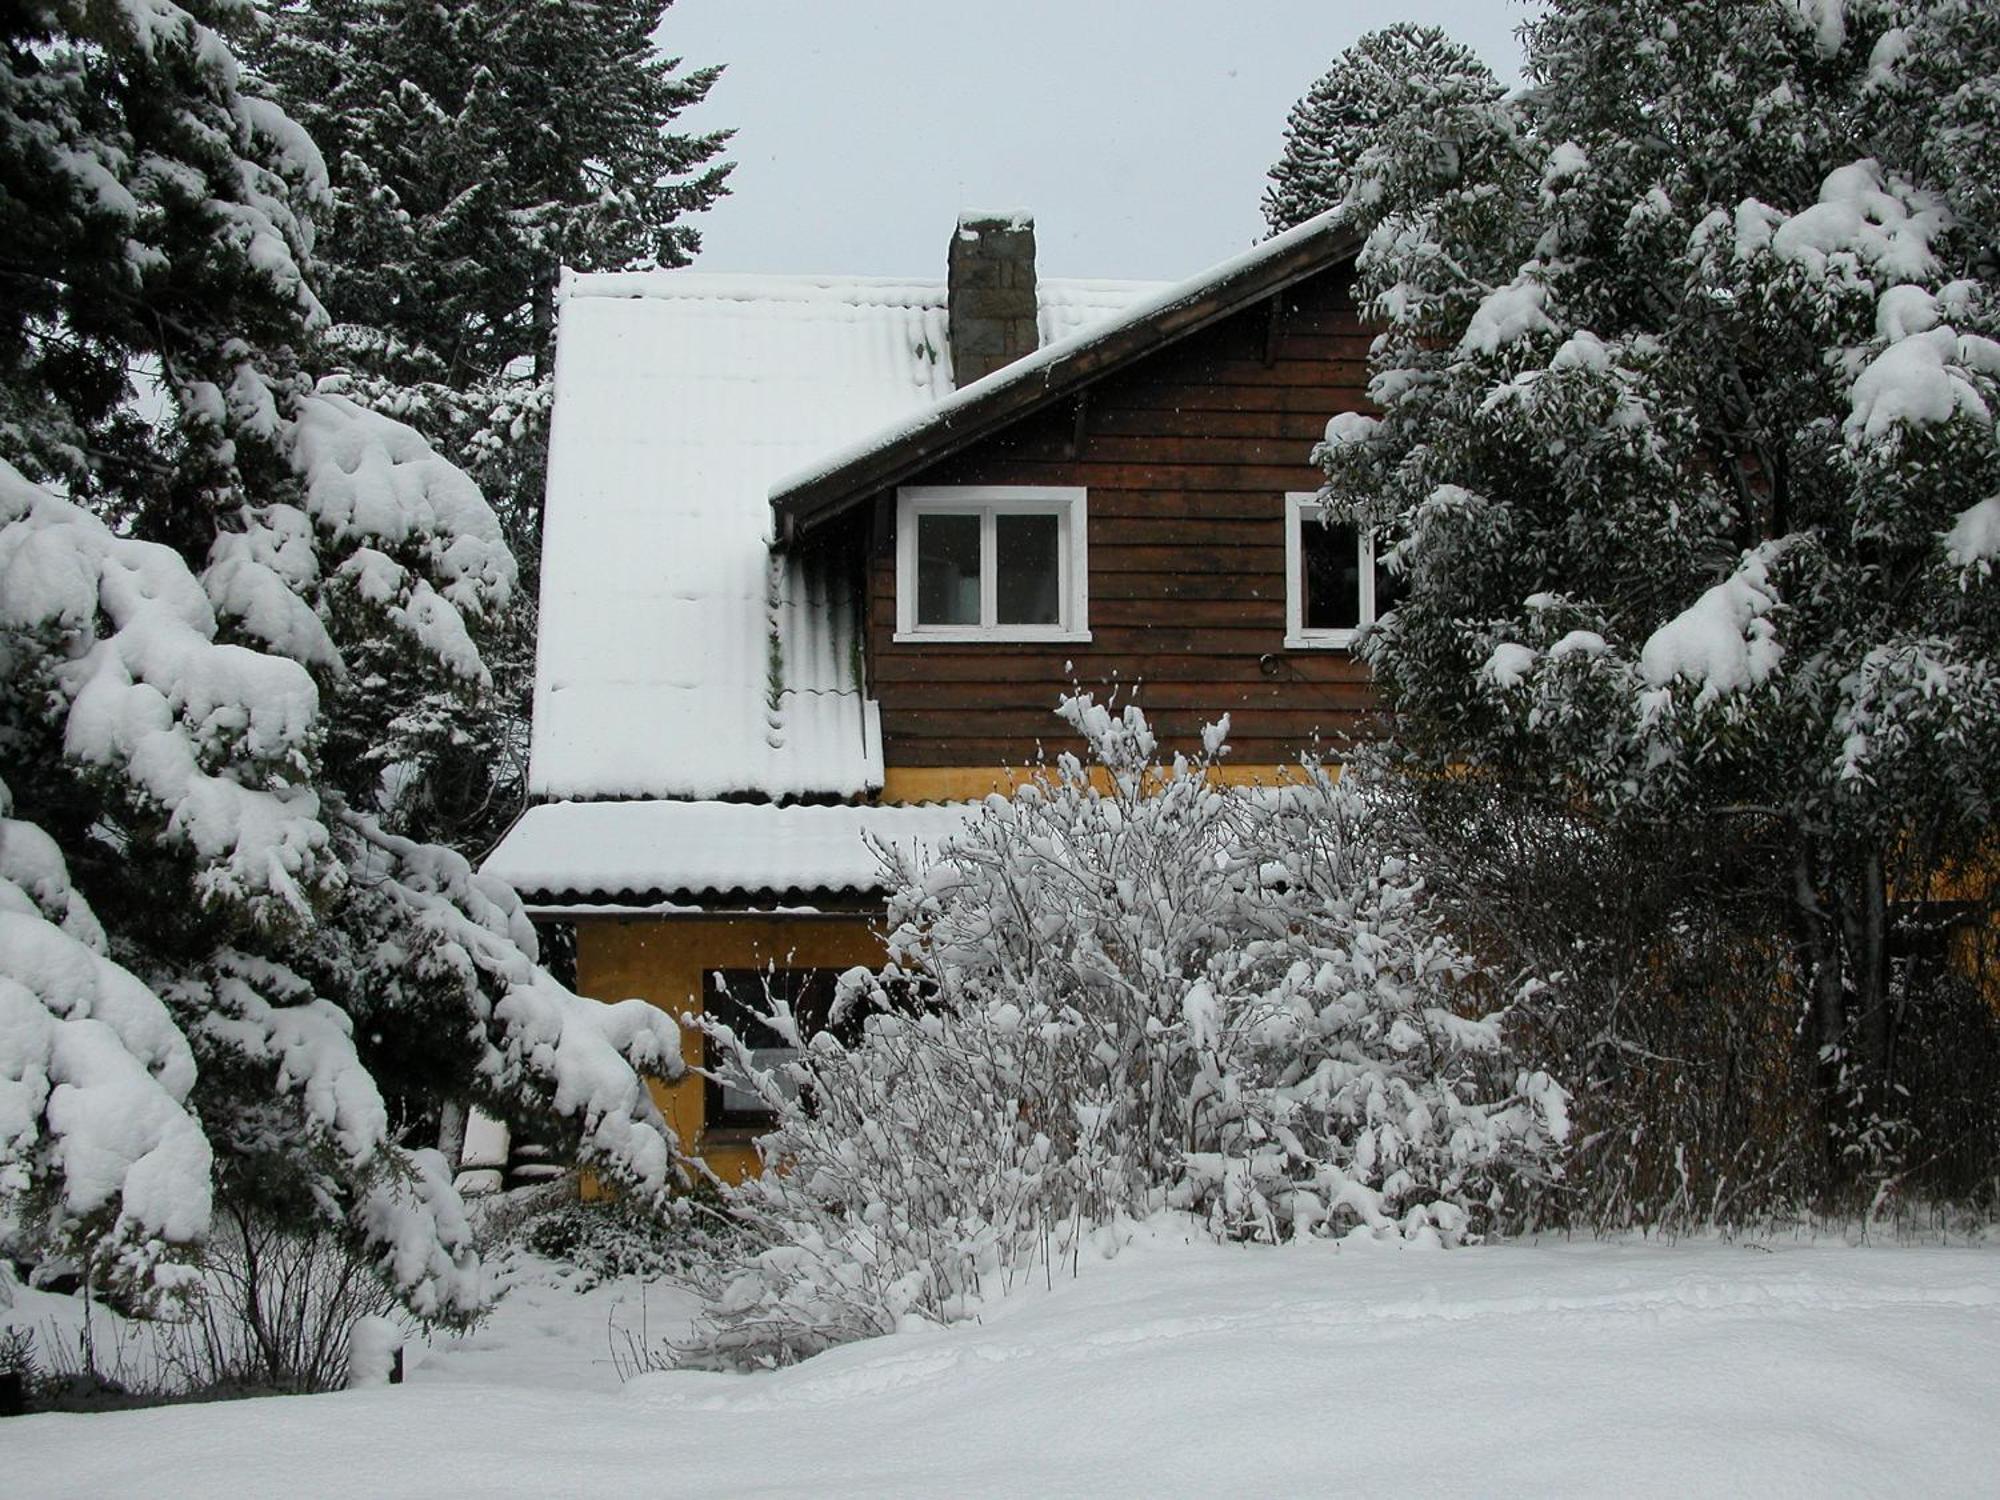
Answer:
[{"xmin": 0, "ymin": 1230, "xmax": 2000, "ymax": 1500}]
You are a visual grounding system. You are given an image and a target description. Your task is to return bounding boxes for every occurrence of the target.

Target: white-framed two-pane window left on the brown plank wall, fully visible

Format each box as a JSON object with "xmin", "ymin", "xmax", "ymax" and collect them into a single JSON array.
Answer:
[{"xmin": 896, "ymin": 484, "xmax": 1090, "ymax": 640}]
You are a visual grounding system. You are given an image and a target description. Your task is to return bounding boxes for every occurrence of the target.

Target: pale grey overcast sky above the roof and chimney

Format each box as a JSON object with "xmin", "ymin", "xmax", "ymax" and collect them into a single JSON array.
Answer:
[{"xmin": 660, "ymin": 0, "xmax": 1528, "ymax": 280}]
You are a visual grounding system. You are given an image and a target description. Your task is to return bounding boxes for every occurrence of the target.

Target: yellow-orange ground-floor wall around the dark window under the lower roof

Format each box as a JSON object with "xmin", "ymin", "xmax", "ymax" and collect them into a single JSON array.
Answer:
[{"xmin": 576, "ymin": 914, "xmax": 884, "ymax": 1182}]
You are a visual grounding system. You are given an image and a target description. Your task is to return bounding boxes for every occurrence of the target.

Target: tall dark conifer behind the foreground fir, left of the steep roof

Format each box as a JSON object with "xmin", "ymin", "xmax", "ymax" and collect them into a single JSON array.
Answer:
[{"xmin": 252, "ymin": 0, "xmax": 728, "ymax": 848}]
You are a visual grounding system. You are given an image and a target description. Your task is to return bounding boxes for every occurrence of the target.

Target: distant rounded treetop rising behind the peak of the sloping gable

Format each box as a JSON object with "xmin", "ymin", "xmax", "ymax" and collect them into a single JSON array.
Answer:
[{"xmin": 1264, "ymin": 20, "xmax": 1502, "ymax": 234}]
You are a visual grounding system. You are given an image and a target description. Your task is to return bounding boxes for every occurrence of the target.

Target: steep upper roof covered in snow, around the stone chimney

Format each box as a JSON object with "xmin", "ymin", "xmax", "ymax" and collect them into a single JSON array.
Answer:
[{"xmin": 530, "ymin": 270, "xmax": 1154, "ymax": 812}]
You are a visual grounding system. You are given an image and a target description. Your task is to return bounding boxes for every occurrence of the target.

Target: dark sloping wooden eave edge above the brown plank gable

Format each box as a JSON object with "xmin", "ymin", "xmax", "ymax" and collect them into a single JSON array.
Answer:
[{"xmin": 770, "ymin": 224, "xmax": 1362, "ymax": 546}]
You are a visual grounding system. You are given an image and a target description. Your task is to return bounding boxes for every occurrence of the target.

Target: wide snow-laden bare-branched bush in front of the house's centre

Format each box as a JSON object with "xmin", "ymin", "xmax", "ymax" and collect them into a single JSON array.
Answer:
[{"xmin": 672, "ymin": 698, "xmax": 1566, "ymax": 1364}]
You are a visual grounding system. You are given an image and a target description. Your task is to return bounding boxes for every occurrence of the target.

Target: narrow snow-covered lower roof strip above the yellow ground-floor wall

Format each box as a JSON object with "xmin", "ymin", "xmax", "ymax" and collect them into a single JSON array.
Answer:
[{"xmin": 480, "ymin": 800, "xmax": 978, "ymax": 900}]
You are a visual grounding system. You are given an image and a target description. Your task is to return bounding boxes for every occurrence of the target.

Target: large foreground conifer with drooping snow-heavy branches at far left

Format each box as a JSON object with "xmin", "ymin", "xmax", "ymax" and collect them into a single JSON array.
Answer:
[{"xmin": 0, "ymin": 0, "xmax": 678, "ymax": 1318}]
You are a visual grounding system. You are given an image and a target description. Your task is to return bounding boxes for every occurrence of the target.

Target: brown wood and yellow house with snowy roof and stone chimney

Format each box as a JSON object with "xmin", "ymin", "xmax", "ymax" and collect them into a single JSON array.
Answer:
[{"xmin": 484, "ymin": 216, "xmax": 1384, "ymax": 1172}]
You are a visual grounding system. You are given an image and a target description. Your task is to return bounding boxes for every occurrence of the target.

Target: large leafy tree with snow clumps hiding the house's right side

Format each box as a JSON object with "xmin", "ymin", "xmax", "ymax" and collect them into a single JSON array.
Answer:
[{"xmin": 1320, "ymin": 0, "xmax": 2000, "ymax": 1168}]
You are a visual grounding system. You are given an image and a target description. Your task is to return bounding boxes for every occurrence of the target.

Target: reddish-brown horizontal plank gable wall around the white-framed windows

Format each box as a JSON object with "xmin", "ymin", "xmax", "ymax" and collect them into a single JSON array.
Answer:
[{"xmin": 866, "ymin": 270, "xmax": 1376, "ymax": 768}]
